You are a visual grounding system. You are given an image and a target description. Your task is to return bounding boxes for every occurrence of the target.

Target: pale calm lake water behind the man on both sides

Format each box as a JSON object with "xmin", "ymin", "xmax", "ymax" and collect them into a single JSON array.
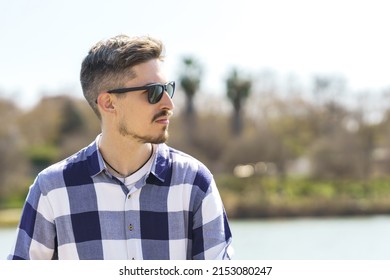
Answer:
[{"xmin": 0, "ymin": 216, "xmax": 390, "ymax": 260}]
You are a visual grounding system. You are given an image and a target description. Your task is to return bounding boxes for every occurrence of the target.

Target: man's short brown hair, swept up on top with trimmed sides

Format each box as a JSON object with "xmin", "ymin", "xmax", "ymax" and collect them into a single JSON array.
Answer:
[{"xmin": 80, "ymin": 35, "xmax": 164, "ymax": 118}]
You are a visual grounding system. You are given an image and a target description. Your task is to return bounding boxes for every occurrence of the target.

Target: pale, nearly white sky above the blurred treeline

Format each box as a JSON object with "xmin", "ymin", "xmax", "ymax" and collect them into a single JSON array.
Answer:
[{"xmin": 0, "ymin": 0, "xmax": 390, "ymax": 106}]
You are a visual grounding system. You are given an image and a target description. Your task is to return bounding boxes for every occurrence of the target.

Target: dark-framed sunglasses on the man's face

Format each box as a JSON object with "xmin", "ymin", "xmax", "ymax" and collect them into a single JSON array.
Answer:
[{"xmin": 107, "ymin": 81, "xmax": 175, "ymax": 104}]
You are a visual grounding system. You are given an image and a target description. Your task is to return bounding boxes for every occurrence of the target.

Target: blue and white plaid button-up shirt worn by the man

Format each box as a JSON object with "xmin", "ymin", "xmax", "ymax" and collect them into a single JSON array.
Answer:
[{"xmin": 8, "ymin": 138, "xmax": 232, "ymax": 260}]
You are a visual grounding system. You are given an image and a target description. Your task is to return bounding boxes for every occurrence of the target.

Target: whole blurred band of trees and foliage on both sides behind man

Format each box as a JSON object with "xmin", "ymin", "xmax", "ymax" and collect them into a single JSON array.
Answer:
[{"xmin": 0, "ymin": 68, "xmax": 390, "ymax": 217}]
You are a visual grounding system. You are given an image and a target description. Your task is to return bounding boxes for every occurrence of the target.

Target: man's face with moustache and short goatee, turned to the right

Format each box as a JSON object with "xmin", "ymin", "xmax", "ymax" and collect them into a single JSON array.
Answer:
[{"xmin": 112, "ymin": 59, "xmax": 174, "ymax": 144}]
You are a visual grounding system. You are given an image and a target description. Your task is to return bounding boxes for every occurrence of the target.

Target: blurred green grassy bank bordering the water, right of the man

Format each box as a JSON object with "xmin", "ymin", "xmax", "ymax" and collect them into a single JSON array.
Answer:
[{"xmin": 216, "ymin": 175, "xmax": 390, "ymax": 218}]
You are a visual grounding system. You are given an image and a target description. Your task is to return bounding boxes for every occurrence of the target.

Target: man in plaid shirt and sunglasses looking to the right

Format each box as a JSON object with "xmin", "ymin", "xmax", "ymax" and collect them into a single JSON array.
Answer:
[{"xmin": 8, "ymin": 35, "xmax": 231, "ymax": 260}]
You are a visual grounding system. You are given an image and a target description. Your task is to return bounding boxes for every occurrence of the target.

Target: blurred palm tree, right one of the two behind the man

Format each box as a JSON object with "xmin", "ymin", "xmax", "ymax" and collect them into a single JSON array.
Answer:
[{"xmin": 226, "ymin": 69, "xmax": 252, "ymax": 136}]
